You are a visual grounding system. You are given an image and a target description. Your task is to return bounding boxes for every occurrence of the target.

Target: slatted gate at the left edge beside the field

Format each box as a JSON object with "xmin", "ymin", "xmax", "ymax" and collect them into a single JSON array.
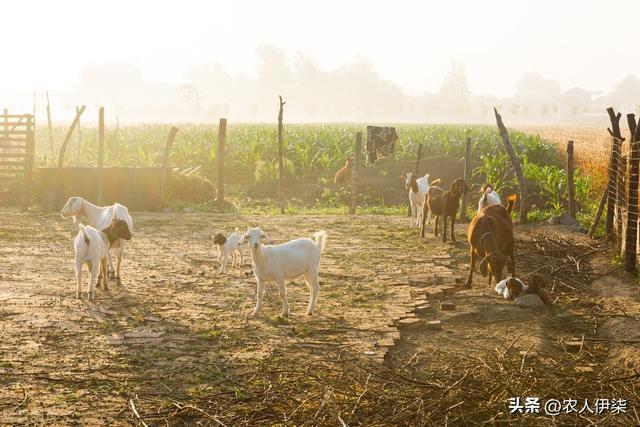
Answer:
[{"xmin": 0, "ymin": 110, "xmax": 35, "ymax": 210}]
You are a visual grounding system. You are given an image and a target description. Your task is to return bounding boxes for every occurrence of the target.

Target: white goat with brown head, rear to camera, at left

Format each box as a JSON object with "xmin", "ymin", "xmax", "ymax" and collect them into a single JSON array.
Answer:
[{"xmin": 73, "ymin": 219, "xmax": 131, "ymax": 300}]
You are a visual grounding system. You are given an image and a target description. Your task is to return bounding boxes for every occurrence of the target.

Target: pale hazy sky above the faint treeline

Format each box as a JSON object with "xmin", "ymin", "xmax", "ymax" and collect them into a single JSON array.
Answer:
[{"xmin": 0, "ymin": 0, "xmax": 640, "ymax": 96}]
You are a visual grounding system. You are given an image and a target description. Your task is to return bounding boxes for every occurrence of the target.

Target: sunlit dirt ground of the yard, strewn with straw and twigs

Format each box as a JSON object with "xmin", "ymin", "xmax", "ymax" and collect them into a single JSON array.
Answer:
[{"xmin": 0, "ymin": 209, "xmax": 640, "ymax": 425}]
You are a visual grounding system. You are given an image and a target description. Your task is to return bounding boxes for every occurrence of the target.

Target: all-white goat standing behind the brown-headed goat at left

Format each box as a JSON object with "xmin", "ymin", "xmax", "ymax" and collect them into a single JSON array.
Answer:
[{"xmin": 60, "ymin": 197, "xmax": 133, "ymax": 285}]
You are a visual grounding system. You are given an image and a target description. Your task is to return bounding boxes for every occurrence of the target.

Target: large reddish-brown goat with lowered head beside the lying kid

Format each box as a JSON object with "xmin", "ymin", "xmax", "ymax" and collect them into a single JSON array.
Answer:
[{"xmin": 466, "ymin": 195, "xmax": 516, "ymax": 287}]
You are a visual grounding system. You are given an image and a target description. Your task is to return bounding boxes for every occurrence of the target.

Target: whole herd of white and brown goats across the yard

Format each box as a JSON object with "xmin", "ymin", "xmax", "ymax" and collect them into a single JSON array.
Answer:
[{"xmin": 61, "ymin": 169, "xmax": 551, "ymax": 316}]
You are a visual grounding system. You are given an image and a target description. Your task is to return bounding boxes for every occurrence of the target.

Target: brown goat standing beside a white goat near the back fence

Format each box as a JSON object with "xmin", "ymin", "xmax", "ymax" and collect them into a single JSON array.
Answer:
[{"xmin": 420, "ymin": 178, "xmax": 469, "ymax": 242}]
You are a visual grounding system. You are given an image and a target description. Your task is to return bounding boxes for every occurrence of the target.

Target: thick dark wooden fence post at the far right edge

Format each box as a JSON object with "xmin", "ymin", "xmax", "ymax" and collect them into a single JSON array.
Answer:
[{"xmin": 624, "ymin": 114, "xmax": 640, "ymax": 273}]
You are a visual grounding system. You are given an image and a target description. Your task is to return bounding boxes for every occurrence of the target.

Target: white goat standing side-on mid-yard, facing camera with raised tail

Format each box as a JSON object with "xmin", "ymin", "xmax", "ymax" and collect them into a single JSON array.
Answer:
[{"xmin": 242, "ymin": 228, "xmax": 327, "ymax": 317}]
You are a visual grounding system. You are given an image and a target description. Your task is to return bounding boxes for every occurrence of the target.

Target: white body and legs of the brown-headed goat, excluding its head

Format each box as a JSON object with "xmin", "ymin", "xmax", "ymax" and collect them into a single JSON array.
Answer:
[{"xmin": 73, "ymin": 224, "xmax": 109, "ymax": 300}]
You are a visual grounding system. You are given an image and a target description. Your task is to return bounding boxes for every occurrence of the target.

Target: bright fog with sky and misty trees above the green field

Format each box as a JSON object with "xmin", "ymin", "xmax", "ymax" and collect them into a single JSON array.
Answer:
[{"xmin": 0, "ymin": 0, "xmax": 640, "ymax": 124}]
